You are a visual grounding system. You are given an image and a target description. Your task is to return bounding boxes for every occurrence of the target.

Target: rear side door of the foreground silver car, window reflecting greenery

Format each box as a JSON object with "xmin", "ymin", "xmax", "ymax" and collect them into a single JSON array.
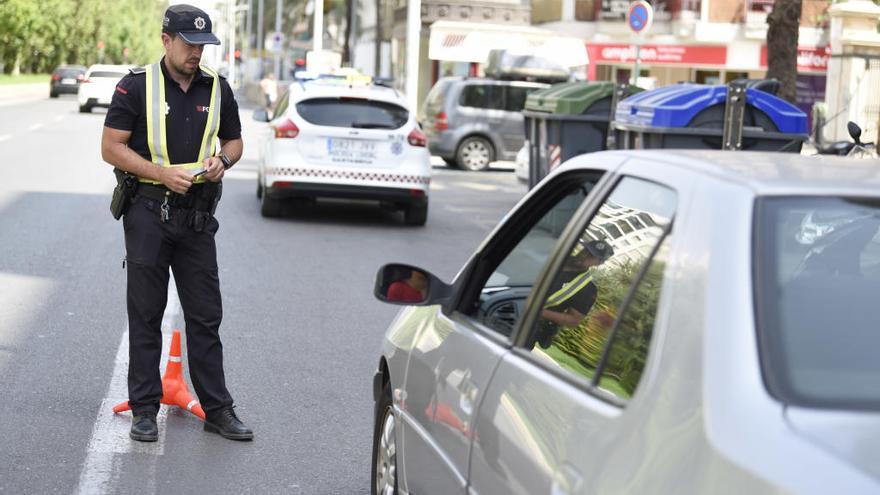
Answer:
[{"xmin": 468, "ymin": 161, "xmax": 687, "ymax": 495}]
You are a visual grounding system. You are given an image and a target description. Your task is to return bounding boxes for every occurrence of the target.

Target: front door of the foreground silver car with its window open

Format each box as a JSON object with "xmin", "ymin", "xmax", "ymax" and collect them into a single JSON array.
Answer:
[{"xmin": 400, "ymin": 166, "xmax": 616, "ymax": 494}]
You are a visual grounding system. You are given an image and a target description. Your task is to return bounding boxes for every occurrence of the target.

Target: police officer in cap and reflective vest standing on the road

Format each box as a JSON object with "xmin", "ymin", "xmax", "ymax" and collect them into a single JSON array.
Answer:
[{"xmin": 101, "ymin": 5, "xmax": 253, "ymax": 442}]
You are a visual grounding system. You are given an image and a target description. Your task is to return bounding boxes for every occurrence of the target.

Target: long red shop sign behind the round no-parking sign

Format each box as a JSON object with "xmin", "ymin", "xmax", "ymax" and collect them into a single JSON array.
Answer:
[{"xmin": 587, "ymin": 44, "xmax": 727, "ymax": 65}]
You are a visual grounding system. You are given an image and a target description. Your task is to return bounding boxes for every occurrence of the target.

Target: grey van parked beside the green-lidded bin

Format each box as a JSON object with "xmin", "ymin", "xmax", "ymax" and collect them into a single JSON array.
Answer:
[{"xmin": 421, "ymin": 77, "xmax": 548, "ymax": 170}]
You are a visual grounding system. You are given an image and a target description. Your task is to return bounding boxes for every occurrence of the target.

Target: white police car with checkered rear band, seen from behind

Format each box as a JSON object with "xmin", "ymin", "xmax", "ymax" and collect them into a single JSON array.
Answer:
[{"xmin": 254, "ymin": 76, "xmax": 431, "ymax": 225}]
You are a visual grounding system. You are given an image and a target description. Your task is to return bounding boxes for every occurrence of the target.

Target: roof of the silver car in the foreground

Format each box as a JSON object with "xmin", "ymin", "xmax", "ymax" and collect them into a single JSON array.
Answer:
[{"xmin": 573, "ymin": 149, "xmax": 880, "ymax": 196}]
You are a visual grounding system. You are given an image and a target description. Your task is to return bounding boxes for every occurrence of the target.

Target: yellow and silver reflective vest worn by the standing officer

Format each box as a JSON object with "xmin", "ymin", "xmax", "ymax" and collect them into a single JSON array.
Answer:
[{"xmin": 138, "ymin": 62, "xmax": 220, "ymax": 184}]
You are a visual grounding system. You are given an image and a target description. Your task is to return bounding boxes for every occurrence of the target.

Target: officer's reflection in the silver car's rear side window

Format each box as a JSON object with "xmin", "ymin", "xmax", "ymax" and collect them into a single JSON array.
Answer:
[{"xmin": 536, "ymin": 241, "xmax": 614, "ymax": 349}]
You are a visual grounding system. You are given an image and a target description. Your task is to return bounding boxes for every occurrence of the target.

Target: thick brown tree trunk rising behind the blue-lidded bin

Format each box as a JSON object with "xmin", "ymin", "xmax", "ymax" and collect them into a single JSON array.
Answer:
[{"xmin": 767, "ymin": 0, "xmax": 801, "ymax": 103}]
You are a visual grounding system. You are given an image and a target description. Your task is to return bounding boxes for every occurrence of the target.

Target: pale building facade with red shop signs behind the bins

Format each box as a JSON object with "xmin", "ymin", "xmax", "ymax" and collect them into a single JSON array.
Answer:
[{"xmin": 532, "ymin": 0, "xmax": 831, "ymax": 130}]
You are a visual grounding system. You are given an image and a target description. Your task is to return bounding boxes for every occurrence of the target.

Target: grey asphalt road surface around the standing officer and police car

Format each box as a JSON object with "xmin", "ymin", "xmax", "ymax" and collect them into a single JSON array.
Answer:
[{"xmin": 0, "ymin": 91, "xmax": 525, "ymax": 495}]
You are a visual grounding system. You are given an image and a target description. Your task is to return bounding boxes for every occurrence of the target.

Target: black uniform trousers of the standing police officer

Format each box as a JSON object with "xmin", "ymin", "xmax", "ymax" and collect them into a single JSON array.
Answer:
[{"xmin": 123, "ymin": 196, "xmax": 233, "ymax": 415}]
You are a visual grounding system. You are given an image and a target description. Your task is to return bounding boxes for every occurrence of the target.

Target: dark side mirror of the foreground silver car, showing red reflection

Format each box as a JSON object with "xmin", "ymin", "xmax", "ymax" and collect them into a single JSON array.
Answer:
[{"xmin": 373, "ymin": 263, "xmax": 452, "ymax": 306}]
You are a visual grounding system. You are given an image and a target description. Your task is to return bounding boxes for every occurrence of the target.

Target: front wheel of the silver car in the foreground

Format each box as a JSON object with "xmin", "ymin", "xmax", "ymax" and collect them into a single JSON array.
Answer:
[{"xmin": 371, "ymin": 383, "xmax": 397, "ymax": 495}]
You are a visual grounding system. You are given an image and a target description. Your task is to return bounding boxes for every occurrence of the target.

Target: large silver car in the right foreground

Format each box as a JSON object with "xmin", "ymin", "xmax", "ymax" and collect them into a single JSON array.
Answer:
[{"xmin": 372, "ymin": 150, "xmax": 880, "ymax": 495}]
